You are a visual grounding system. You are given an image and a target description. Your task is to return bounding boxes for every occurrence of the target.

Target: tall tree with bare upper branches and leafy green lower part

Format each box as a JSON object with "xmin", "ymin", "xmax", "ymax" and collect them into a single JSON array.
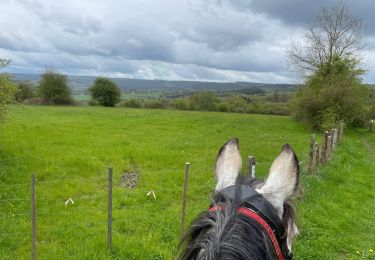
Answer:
[{"xmin": 288, "ymin": 0, "xmax": 366, "ymax": 130}]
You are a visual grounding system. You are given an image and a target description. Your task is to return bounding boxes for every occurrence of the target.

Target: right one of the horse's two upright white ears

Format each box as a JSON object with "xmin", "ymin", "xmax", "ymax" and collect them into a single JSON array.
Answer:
[{"xmin": 258, "ymin": 144, "xmax": 299, "ymax": 218}]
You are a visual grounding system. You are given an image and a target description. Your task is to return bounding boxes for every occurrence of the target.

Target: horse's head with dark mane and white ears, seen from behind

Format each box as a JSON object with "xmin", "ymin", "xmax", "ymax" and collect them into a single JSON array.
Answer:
[{"xmin": 179, "ymin": 139, "xmax": 299, "ymax": 260}]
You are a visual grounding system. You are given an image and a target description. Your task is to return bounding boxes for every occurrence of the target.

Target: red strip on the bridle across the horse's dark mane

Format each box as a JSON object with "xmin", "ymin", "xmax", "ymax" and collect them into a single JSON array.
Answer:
[{"xmin": 209, "ymin": 206, "xmax": 284, "ymax": 260}]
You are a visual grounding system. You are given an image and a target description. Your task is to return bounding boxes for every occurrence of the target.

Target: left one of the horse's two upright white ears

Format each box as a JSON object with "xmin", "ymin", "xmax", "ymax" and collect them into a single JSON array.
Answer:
[{"xmin": 215, "ymin": 138, "xmax": 242, "ymax": 191}]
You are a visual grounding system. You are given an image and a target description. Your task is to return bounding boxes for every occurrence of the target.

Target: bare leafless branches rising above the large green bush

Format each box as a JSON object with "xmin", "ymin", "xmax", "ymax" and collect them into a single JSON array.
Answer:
[{"xmin": 288, "ymin": 0, "xmax": 365, "ymax": 76}]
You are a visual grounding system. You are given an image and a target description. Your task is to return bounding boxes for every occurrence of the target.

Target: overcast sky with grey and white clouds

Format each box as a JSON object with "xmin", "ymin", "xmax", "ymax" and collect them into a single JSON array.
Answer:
[{"xmin": 0, "ymin": 0, "xmax": 375, "ymax": 83}]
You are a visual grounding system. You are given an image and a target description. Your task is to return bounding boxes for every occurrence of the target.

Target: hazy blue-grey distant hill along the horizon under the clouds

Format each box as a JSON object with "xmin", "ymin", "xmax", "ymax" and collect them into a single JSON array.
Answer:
[{"xmin": 13, "ymin": 73, "xmax": 296, "ymax": 93}]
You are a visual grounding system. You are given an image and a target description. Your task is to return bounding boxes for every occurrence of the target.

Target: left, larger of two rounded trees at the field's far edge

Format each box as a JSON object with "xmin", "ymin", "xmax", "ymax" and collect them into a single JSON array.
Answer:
[{"xmin": 39, "ymin": 69, "xmax": 73, "ymax": 105}]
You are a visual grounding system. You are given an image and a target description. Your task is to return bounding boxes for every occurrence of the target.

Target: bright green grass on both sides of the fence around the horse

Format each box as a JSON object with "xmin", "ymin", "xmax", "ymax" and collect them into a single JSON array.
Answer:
[{"xmin": 0, "ymin": 106, "xmax": 375, "ymax": 259}]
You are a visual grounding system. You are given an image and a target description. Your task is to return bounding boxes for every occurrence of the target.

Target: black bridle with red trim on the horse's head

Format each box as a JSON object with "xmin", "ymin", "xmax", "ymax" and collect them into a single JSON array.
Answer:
[{"xmin": 209, "ymin": 185, "xmax": 293, "ymax": 260}]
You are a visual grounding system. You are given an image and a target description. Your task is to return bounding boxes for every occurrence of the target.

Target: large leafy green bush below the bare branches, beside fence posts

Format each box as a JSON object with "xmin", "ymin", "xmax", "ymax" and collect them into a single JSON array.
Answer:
[{"xmin": 291, "ymin": 57, "xmax": 367, "ymax": 130}]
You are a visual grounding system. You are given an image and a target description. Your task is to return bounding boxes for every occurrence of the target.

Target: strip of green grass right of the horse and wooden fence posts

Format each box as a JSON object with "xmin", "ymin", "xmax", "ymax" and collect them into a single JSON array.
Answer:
[{"xmin": 295, "ymin": 129, "xmax": 375, "ymax": 259}]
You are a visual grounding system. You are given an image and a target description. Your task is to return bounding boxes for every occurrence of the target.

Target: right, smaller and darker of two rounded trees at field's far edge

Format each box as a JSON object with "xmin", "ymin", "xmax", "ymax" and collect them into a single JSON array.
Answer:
[{"xmin": 89, "ymin": 77, "xmax": 121, "ymax": 107}]
